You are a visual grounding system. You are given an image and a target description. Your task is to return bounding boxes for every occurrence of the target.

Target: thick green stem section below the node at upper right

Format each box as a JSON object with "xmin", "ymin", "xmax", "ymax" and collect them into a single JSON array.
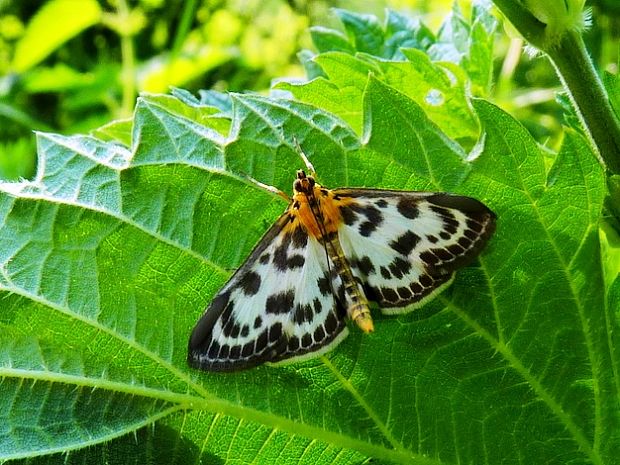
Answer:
[{"xmin": 546, "ymin": 32, "xmax": 620, "ymax": 174}]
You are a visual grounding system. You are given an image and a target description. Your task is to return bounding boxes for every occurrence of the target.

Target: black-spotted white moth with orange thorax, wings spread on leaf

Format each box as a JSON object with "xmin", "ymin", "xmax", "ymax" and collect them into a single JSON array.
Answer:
[{"xmin": 188, "ymin": 154, "xmax": 496, "ymax": 371}]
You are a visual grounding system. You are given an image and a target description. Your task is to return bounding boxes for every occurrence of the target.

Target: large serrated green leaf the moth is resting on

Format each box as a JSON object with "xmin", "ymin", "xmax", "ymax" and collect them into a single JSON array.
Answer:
[{"xmin": 0, "ymin": 5, "xmax": 620, "ymax": 465}]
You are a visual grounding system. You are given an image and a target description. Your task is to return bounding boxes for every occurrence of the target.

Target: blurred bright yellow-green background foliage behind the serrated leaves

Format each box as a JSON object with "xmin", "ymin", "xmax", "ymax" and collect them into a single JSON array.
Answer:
[{"xmin": 0, "ymin": 0, "xmax": 620, "ymax": 179}]
